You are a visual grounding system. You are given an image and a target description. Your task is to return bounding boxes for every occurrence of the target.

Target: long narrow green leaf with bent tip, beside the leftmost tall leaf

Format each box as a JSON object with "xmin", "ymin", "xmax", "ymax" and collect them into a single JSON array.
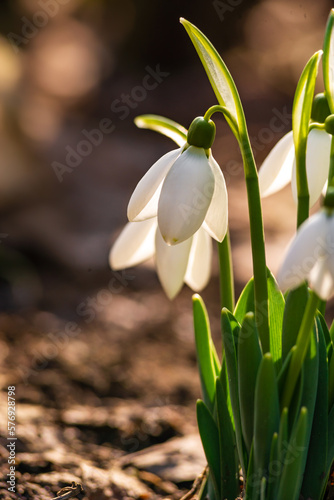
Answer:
[{"xmin": 221, "ymin": 308, "xmax": 247, "ymax": 472}]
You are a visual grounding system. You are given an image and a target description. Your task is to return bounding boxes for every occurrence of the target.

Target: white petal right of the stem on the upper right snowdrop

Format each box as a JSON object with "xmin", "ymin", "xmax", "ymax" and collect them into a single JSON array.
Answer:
[{"xmin": 291, "ymin": 129, "xmax": 331, "ymax": 207}]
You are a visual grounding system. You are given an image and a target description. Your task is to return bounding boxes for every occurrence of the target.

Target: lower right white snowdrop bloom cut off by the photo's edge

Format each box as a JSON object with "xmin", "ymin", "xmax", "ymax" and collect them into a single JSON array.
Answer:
[{"xmin": 277, "ymin": 209, "xmax": 334, "ymax": 300}]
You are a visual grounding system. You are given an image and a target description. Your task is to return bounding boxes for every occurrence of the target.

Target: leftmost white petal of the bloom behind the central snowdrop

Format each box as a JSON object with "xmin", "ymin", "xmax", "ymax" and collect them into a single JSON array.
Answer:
[{"xmin": 109, "ymin": 219, "xmax": 157, "ymax": 270}]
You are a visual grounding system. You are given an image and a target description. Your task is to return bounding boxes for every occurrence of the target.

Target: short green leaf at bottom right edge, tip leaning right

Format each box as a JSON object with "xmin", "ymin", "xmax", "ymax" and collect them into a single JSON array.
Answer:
[{"xmin": 276, "ymin": 408, "xmax": 308, "ymax": 500}]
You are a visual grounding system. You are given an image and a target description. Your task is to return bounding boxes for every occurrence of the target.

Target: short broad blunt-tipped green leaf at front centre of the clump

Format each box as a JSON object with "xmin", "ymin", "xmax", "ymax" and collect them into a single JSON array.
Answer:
[{"xmin": 254, "ymin": 353, "xmax": 280, "ymax": 471}]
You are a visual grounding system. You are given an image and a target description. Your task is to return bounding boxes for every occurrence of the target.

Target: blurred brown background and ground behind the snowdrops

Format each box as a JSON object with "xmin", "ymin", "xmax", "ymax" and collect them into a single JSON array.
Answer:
[{"xmin": 0, "ymin": 0, "xmax": 331, "ymax": 500}]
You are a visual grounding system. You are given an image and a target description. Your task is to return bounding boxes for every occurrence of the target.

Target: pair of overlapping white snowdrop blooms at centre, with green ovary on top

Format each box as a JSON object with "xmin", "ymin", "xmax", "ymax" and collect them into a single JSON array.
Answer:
[{"xmin": 110, "ymin": 118, "xmax": 228, "ymax": 299}]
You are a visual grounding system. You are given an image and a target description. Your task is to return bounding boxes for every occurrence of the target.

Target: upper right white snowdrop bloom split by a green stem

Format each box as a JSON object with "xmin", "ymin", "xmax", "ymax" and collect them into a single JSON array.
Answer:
[{"xmin": 259, "ymin": 129, "xmax": 332, "ymax": 207}]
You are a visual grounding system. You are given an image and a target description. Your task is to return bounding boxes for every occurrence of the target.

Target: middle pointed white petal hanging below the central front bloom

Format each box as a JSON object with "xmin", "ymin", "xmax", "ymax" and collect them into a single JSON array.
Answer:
[{"xmin": 155, "ymin": 229, "xmax": 192, "ymax": 299}]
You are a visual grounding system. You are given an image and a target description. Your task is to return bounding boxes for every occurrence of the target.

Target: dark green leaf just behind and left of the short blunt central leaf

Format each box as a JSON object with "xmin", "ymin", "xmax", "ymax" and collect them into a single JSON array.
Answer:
[{"xmin": 238, "ymin": 313, "xmax": 262, "ymax": 453}]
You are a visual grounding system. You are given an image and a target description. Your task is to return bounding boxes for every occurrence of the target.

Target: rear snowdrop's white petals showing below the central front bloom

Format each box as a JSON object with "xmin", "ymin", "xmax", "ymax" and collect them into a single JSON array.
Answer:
[{"xmin": 109, "ymin": 217, "xmax": 212, "ymax": 299}]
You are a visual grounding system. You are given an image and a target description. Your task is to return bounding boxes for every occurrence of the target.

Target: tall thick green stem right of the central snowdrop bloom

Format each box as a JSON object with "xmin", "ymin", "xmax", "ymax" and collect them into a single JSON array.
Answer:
[{"xmin": 239, "ymin": 130, "xmax": 270, "ymax": 353}]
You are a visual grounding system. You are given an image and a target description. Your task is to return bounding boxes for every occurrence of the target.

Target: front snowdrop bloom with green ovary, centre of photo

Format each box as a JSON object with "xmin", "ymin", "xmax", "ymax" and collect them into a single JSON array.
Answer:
[{"xmin": 128, "ymin": 117, "xmax": 228, "ymax": 245}]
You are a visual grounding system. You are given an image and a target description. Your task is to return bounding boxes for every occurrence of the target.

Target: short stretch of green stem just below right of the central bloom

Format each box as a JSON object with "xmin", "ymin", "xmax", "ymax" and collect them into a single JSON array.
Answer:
[{"xmin": 218, "ymin": 230, "xmax": 234, "ymax": 312}]
